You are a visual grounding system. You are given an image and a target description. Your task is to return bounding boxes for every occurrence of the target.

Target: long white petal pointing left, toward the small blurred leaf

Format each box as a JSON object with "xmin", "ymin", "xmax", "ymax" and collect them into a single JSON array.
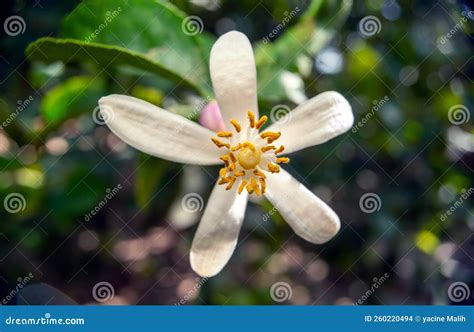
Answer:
[{"xmin": 99, "ymin": 95, "xmax": 222, "ymax": 165}]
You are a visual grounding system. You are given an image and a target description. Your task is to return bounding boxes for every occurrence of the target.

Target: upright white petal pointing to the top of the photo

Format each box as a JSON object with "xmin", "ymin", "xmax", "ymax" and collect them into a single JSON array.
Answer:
[{"xmin": 209, "ymin": 31, "xmax": 258, "ymax": 127}]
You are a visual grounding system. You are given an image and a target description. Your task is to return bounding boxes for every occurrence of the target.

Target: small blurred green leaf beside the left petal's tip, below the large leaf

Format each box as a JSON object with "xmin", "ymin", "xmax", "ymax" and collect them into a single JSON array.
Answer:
[{"xmin": 40, "ymin": 76, "xmax": 105, "ymax": 126}]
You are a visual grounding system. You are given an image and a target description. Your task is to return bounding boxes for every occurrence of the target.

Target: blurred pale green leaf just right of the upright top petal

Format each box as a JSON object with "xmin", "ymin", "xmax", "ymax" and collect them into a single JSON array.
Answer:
[{"xmin": 255, "ymin": 0, "xmax": 352, "ymax": 102}]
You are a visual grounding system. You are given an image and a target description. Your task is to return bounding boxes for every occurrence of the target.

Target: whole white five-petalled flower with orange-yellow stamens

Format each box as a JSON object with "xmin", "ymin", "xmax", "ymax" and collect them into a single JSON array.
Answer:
[{"xmin": 99, "ymin": 31, "xmax": 354, "ymax": 277}]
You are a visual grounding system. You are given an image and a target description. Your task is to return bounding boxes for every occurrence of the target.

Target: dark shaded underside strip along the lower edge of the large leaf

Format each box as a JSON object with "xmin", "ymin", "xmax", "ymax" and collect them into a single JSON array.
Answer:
[{"xmin": 26, "ymin": 37, "xmax": 202, "ymax": 93}]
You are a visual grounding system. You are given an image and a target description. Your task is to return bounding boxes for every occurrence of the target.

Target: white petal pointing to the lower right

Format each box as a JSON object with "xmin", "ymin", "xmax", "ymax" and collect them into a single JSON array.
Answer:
[{"xmin": 265, "ymin": 169, "xmax": 340, "ymax": 244}]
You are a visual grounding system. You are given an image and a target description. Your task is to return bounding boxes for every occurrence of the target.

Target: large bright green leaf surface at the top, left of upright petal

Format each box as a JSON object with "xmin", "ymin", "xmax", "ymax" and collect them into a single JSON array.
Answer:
[{"xmin": 61, "ymin": 0, "xmax": 210, "ymax": 94}]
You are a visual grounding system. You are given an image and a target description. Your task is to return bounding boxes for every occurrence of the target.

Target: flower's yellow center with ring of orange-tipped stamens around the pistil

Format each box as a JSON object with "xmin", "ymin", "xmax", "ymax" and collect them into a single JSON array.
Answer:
[{"xmin": 211, "ymin": 112, "xmax": 290, "ymax": 196}]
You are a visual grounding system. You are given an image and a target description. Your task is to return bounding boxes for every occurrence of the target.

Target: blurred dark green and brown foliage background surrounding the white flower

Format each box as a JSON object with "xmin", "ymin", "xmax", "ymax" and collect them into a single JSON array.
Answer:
[{"xmin": 0, "ymin": 0, "xmax": 474, "ymax": 304}]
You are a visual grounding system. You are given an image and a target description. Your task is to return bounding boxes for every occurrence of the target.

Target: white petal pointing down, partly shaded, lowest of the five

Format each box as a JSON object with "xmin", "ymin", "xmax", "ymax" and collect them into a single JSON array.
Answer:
[{"xmin": 190, "ymin": 184, "xmax": 247, "ymax": 277}]
